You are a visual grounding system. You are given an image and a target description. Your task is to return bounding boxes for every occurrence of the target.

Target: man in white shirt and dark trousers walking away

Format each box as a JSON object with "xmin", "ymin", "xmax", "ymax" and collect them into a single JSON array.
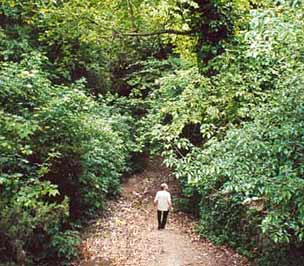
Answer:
[{"xmin": 154, "ymin": 183, "xmax": 172, "ymax": 230}]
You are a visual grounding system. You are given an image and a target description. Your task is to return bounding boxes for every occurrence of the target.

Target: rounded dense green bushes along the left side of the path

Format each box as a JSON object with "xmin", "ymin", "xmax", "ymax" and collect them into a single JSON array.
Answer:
[{"xmin": 0, "ymin": 55, "xmax": 132, "ymax": 264}]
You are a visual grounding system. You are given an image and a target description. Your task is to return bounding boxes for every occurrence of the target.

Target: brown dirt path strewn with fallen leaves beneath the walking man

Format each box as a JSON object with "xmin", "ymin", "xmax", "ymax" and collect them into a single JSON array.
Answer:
[{"xmin": 78, "ymin": 160, "xmax": 247, "ymax": 266}]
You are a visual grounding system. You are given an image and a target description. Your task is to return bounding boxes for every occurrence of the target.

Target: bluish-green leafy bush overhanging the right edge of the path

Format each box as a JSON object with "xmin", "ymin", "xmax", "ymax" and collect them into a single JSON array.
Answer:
[{"xmin": 185, "ymin": 74, "xmax": 304, "ymax": 265}]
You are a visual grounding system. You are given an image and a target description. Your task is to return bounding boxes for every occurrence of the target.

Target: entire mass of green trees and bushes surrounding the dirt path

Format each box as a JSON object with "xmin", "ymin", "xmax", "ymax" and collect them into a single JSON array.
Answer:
[{"xmin": 0, "ymin": 0, "xmax": 304, "ymax": 266}]
